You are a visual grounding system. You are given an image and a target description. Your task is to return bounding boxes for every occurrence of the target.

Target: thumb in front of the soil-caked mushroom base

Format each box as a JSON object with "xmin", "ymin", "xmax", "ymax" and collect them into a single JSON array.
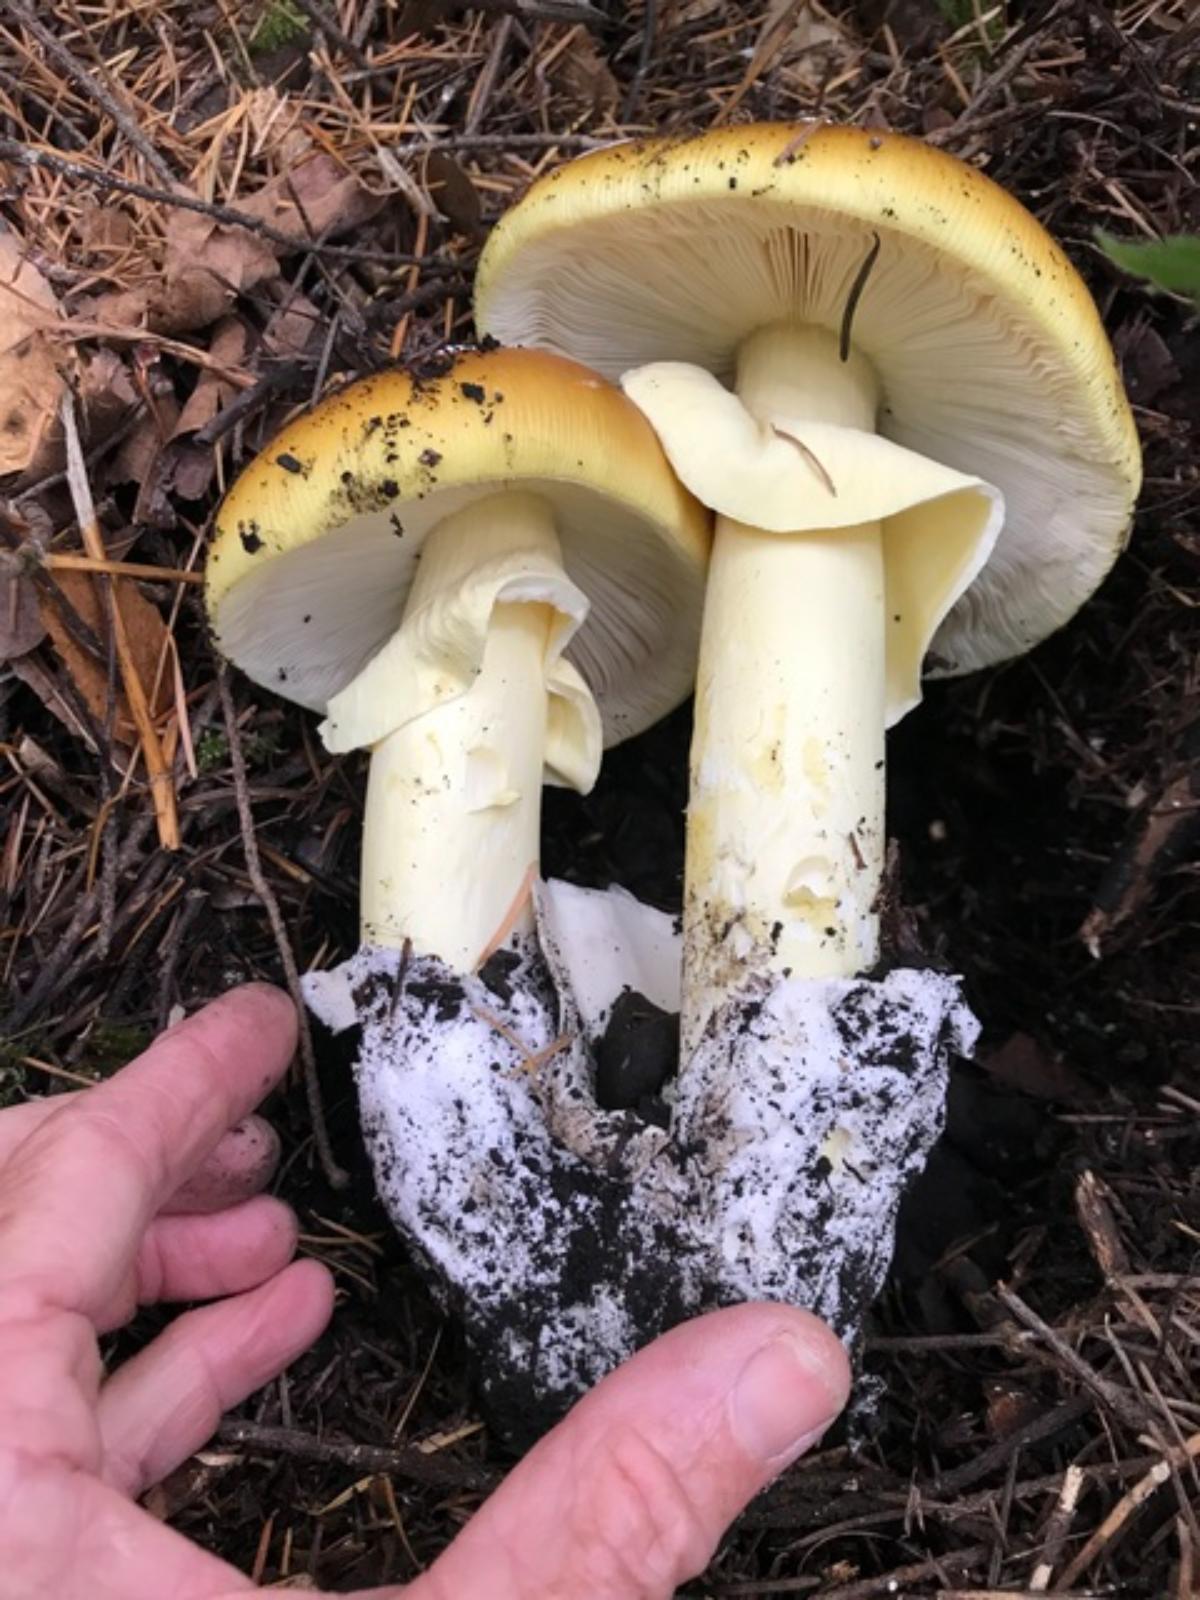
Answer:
[{"xmin": 405, "ymin": 1306, "xmax": 850, "ymax": 1600}]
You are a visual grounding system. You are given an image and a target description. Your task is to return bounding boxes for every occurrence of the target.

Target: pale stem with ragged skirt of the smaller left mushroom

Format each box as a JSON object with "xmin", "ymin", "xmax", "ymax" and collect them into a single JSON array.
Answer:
[{"xmin": 325, "ymin": 493, "xmax": 602, "ymax": 971}]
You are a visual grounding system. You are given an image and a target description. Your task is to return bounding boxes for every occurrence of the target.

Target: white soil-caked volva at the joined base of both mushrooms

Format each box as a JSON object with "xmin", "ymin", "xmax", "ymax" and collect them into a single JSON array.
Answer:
[{"xmin": 306, "ymin": 891, "xmax": 978, "ymax": 1434}]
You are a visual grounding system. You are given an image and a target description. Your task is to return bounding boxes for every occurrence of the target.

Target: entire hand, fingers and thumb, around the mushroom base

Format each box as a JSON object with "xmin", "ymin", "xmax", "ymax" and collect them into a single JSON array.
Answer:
[{"xmin": 0, "ymin": 987, "xmax": 848, "ymax": 1600}]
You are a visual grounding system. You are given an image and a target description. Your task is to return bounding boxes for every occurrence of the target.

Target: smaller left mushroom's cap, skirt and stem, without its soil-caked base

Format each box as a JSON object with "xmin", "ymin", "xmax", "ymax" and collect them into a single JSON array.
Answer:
[{"xmin": 206, "ymin": 350, "xmax": 707, "ymax": 973}]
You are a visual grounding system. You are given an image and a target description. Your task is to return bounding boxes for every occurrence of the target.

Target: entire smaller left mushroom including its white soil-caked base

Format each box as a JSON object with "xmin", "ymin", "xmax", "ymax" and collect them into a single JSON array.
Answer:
[{"xmin": 206, "ymin": 349, "xmax": 723, "ymax": 1435}]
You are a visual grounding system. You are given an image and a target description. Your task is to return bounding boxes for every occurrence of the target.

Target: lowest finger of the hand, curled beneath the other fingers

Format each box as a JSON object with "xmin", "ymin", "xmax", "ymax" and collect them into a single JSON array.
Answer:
[{"xmin": 98, "ymin": 1261, "xmax": 333, "ymax": 1497}]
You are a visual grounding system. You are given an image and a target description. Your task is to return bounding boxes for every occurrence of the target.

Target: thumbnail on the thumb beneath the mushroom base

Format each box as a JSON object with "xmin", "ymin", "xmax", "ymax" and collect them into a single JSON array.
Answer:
[{"xmin": 730, "ymin": 1333, "xmax": 846, "ymax": 1470}]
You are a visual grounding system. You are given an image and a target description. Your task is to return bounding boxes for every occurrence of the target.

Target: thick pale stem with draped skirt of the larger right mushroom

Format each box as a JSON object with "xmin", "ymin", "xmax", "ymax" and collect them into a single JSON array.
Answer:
[{"xmin": 624, "ymin": 323, "xmax": 1003, "ymax": 1061}]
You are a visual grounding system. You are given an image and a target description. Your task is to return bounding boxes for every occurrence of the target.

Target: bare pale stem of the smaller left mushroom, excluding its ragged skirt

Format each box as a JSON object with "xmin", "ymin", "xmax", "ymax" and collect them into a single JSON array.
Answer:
[{"xmin": 362, "ymin": 493, "xmax": 562, "ymax": 971}]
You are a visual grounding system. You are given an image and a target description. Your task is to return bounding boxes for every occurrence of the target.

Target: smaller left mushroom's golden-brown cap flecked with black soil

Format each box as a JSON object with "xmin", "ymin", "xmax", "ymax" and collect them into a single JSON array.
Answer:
[{"xmin": 206, "ymin": 349, "xmax": 709, "ymax": 744}]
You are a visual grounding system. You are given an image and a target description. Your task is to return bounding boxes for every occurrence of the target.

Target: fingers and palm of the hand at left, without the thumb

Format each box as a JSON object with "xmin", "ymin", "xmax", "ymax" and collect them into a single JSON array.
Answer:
[{"xmin": 0, "ymin": 986, "xmax": 333, "ymax": 1600}]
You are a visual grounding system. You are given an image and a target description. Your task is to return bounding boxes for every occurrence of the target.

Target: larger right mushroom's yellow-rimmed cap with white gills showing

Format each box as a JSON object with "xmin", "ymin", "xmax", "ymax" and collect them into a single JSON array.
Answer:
[{"xmin": 475, "ymin": 123, "xmax": 1141, "ymax": 674}]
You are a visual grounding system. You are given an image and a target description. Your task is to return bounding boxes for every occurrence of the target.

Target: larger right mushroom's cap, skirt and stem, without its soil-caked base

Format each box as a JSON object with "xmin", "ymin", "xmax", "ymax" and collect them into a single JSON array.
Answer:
[{"xmin": 477, "ymin": 125, "xmax": 1139, "ymax": 1059}]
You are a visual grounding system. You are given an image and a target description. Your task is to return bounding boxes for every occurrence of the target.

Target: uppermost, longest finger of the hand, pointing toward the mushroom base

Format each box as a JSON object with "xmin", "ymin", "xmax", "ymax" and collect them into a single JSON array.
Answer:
[{"xmin": 0, "ymin": 984, "xmax": 296, "ymax": 1315}]
